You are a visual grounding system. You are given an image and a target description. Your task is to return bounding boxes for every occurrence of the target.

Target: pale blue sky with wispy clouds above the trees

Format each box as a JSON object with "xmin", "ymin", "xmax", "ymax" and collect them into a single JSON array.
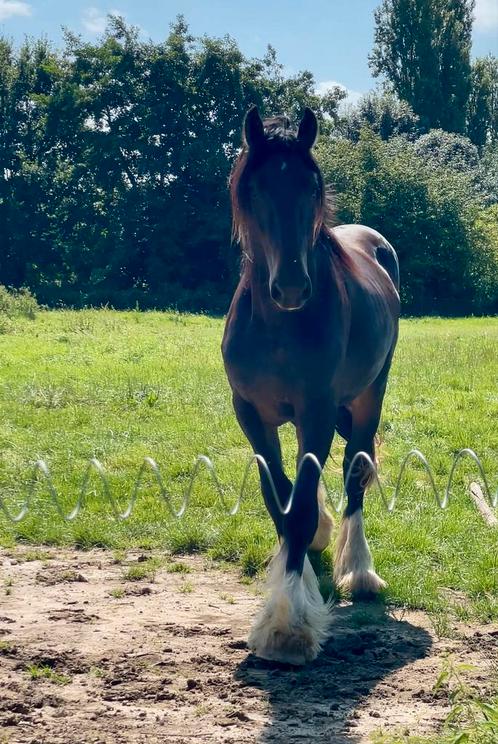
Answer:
[{"xmin": 0, "ymin": 0, "xmax": 498, "ymax": 99}]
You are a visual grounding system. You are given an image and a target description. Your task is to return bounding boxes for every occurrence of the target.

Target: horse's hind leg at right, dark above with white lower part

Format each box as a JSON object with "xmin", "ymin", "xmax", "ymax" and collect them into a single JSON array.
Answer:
[{"xmin": 334, "ymin": 372, "xmax": 387, "ymax": 597}]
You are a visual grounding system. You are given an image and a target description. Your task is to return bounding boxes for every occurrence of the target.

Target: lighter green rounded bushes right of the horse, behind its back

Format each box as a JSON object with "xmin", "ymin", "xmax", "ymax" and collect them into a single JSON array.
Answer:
[{"xmin": 320, "ymin": 129, "xmax": 498, "ymax": 314}]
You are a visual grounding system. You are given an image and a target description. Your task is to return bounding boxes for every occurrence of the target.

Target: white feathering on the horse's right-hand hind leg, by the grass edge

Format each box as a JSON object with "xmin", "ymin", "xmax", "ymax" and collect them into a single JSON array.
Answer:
[{"xmin": 334, "ymin": 509, "xmax": 386, "ymax": 595}]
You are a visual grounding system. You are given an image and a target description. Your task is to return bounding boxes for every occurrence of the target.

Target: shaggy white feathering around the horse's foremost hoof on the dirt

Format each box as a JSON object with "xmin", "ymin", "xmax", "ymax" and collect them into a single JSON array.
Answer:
[{"xmin": 248, "ymin": 545, "xmax": 330, "ymax": 664}]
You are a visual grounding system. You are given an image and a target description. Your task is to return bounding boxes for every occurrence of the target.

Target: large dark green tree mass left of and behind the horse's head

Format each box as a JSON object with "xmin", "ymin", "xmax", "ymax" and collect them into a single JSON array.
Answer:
[{"xmin": 0, "ymin": 17, "xmax": 344, "ymax": 309}]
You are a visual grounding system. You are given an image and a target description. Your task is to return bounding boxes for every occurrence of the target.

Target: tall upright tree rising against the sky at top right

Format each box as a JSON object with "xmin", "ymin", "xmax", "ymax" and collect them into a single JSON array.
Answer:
[{"xmin": 370, "ymin": 0, "xmax": 474, "ymax": 132}]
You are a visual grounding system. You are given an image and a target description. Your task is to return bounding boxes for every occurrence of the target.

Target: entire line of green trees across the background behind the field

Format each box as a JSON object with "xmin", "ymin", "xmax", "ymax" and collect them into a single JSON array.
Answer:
[{"xmin": 0, "ymin": 0, "xmax": 498, "ymax": 313}]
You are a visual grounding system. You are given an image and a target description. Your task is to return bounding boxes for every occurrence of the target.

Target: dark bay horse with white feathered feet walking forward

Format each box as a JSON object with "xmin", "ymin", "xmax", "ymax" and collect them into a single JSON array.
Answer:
[{"xmin": 222, "ymin": 108, "xmax": 399, "ymax": 664}]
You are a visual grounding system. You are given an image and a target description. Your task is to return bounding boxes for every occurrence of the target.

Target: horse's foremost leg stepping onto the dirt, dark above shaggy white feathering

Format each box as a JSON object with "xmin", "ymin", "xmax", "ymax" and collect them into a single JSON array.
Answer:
[{"xmin": 244, "ymin": 406, "xmax": 334, "ymax": 664}]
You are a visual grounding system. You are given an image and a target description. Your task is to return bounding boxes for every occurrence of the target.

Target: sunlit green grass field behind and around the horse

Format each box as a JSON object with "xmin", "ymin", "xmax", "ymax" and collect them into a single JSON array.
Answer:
[{"xmin": 0, "ymin": 310, "xmax": 498, "ymax": 631}]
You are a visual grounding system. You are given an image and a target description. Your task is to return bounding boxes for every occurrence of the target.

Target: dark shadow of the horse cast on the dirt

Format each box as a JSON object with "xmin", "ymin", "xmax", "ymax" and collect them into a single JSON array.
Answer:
[{"xmin": 235, "ymin": 603, "xmax": 432, "ymax": 744}]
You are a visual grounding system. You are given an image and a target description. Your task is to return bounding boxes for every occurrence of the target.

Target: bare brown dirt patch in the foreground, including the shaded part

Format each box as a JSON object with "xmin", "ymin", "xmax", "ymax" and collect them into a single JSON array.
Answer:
[{"xmin": 0, "ymin": 548, "xmax": 498, "ymax": 744}]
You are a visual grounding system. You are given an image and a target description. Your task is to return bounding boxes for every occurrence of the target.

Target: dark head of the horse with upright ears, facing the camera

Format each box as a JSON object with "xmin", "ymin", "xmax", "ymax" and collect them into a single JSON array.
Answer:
[{"xmin": 231, "ymin": 107, "xmax": 326, "ymax": 310}]
